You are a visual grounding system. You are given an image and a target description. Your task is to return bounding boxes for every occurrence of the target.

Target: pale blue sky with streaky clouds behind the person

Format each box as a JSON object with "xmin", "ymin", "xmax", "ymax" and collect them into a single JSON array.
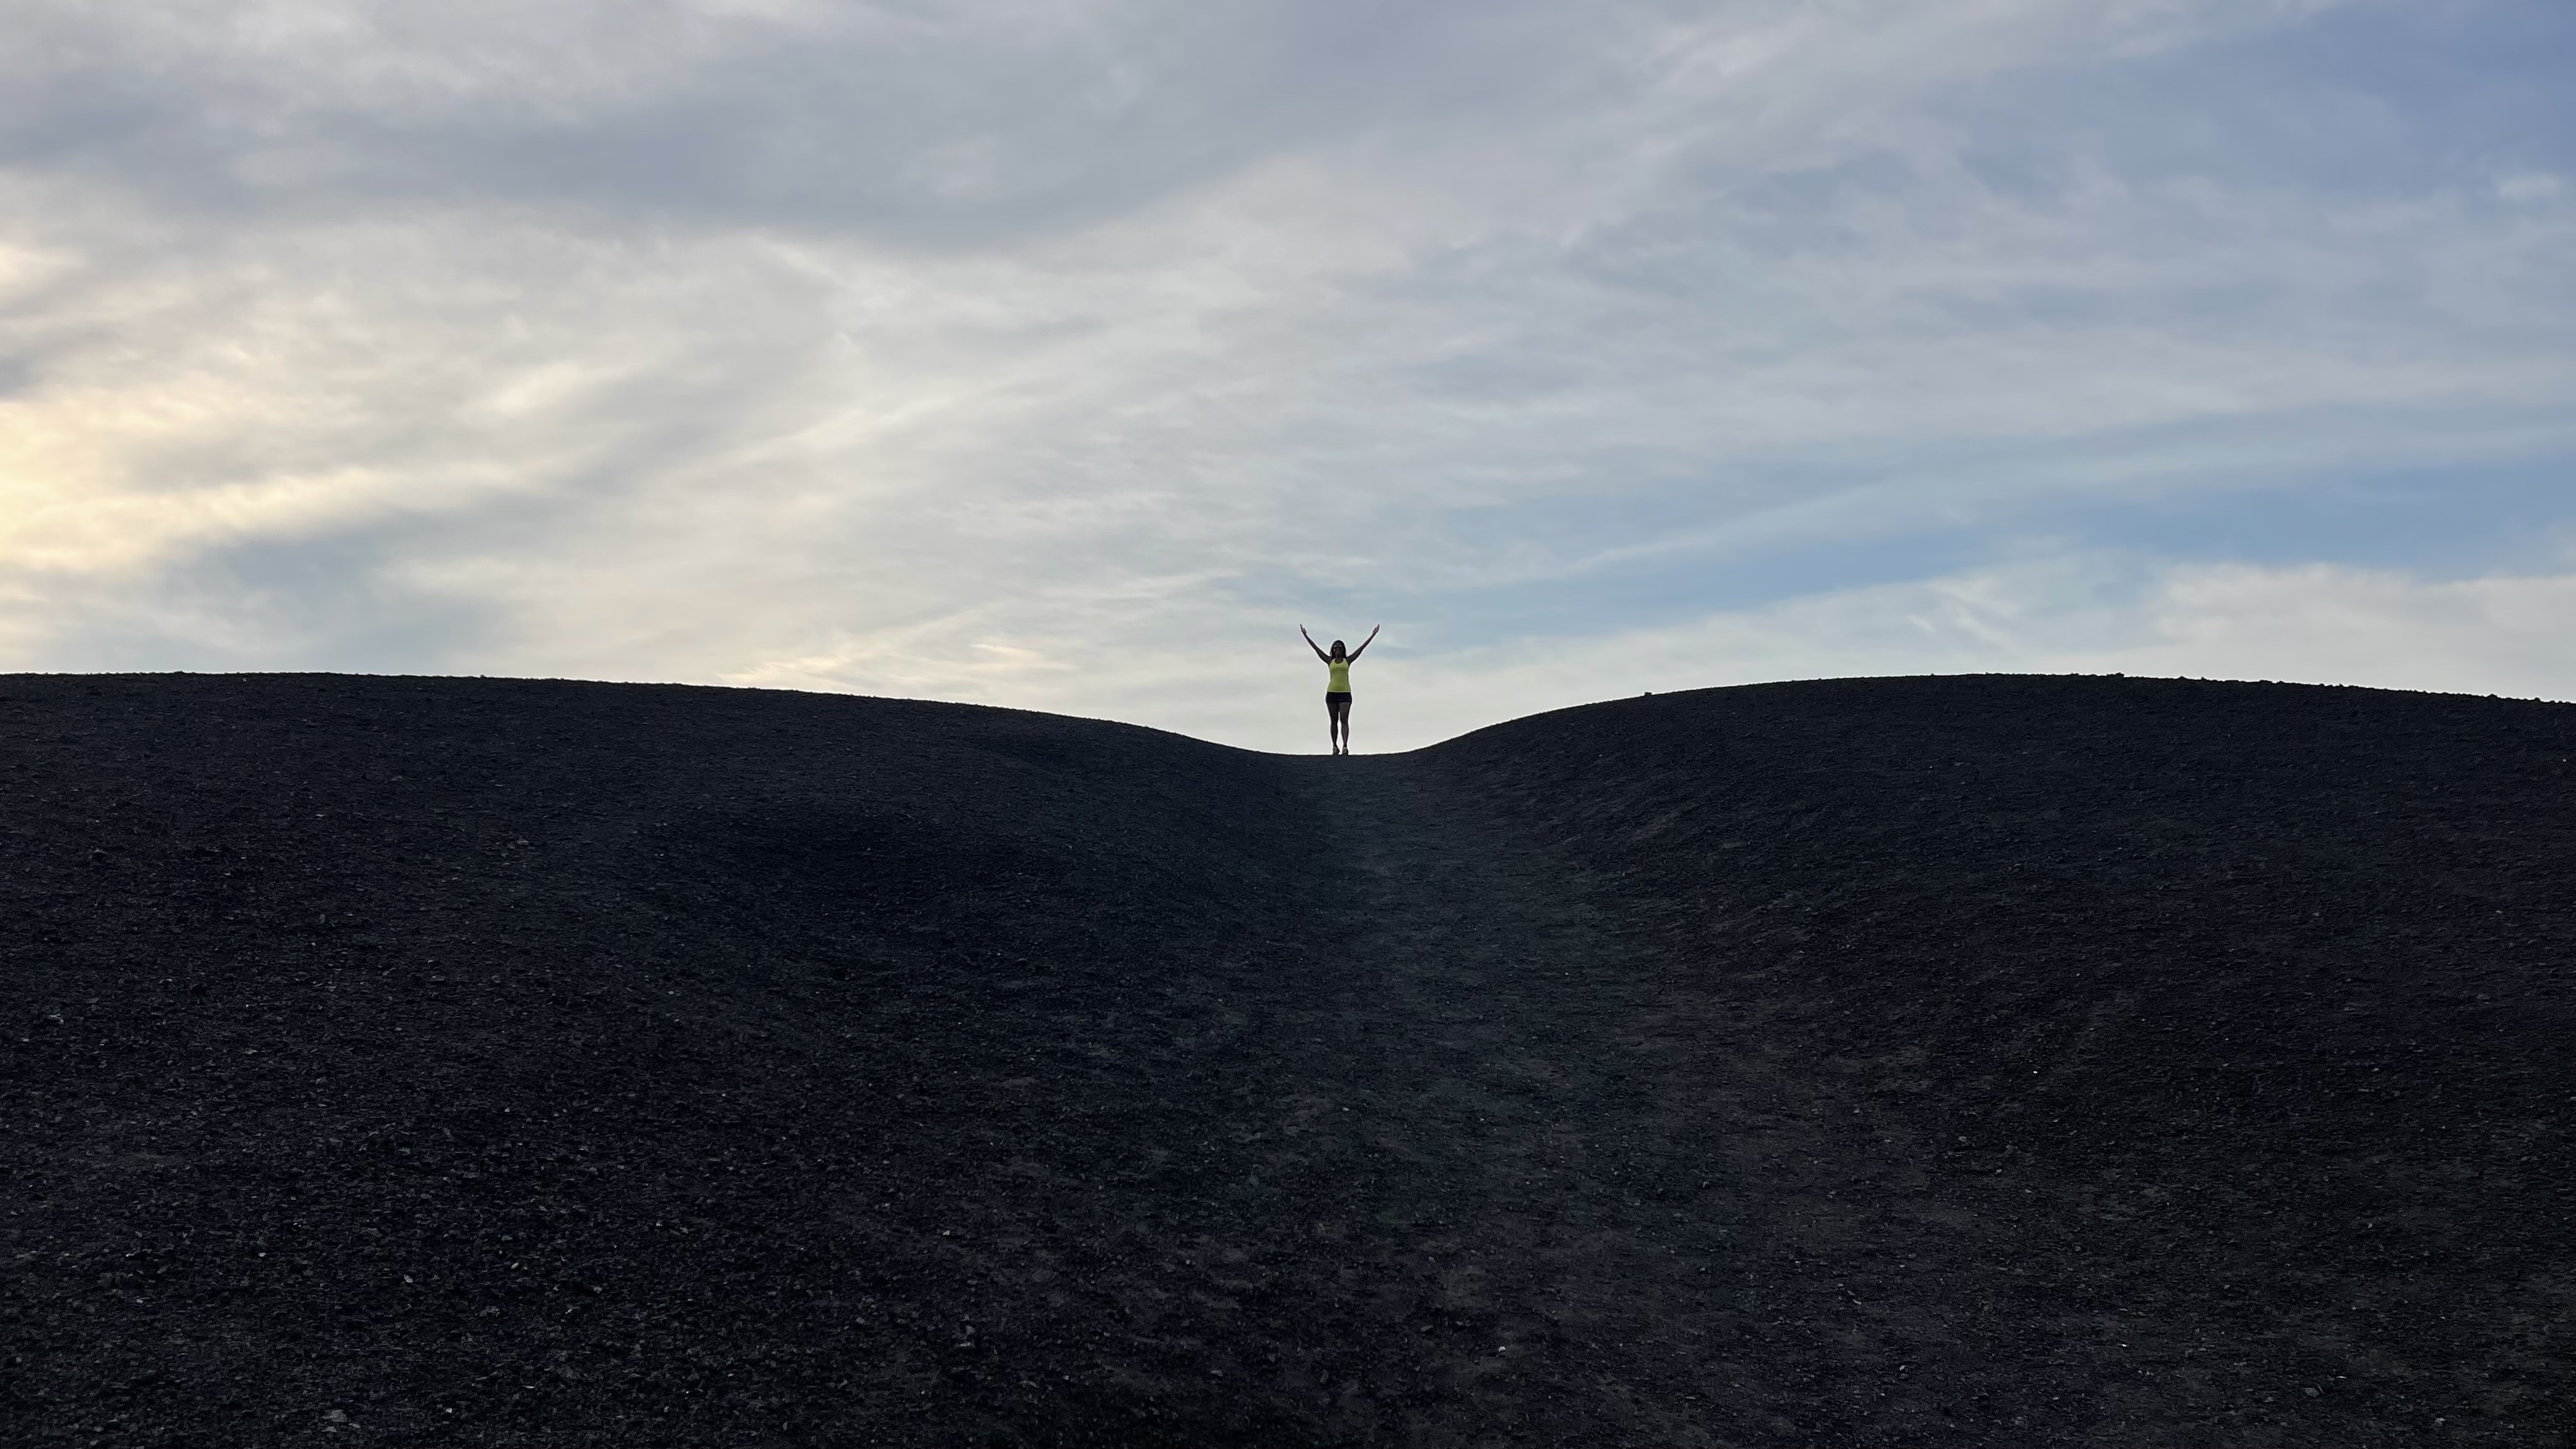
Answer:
[{"xmin": 0, "ymin": 0, "xmax": 2576, "ymax": 750}]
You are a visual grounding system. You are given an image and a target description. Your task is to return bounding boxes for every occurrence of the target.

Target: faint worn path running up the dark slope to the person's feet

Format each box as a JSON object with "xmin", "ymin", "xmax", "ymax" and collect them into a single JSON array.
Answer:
[{"xmin": 1262, "ymin": 755, "xmax": 1960, "ymax": 1444}]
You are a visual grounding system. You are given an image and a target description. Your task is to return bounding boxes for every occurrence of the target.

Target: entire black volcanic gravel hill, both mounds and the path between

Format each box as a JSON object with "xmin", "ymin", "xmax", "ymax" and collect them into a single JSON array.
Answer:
[{"xmin": 0, "ymin": 675, "xmax": 2576, "ymax": 1446}]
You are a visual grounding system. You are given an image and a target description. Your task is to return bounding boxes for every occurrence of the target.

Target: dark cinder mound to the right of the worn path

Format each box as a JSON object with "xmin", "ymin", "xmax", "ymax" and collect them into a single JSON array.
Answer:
[{"xmin": 1427, "ymin": 678, "xmax": 2576, "ymax": 1444}]
